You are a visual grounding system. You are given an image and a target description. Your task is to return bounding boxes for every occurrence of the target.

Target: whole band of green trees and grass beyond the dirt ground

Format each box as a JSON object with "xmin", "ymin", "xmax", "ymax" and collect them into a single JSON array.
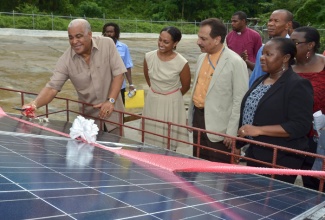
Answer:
[{"xmin": 0, "ymin": 0, "xmax": 325, "ymax": 51}]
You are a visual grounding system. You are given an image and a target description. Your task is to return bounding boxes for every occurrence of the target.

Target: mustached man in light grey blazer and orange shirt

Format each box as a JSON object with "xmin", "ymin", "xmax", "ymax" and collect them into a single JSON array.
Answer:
[{"xmin": 188, "ymin": 18, "xmax": 248, "ymax": 163}]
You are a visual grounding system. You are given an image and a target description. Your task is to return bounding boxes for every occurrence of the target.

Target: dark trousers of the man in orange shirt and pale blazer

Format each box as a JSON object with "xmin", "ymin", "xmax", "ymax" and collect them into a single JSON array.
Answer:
[{"xmin": 193, "ymin": 107, "xmax": 231, "ymax": 163}]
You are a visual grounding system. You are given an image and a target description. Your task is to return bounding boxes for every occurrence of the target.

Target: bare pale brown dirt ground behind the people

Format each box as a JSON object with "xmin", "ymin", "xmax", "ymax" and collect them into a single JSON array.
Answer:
[{"xmin": 0, "ymin": 32, "xmax": 200, "ymax": 113}]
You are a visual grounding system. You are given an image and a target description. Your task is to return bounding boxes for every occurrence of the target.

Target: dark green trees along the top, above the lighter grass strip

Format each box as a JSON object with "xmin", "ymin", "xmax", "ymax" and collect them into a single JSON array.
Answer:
[{"xmin": 0, "ymin": 0, "xmax": 325, "ymax": 28}]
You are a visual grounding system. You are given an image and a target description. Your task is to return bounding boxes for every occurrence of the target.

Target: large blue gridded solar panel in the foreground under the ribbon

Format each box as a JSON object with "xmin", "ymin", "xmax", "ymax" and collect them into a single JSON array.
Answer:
[{"xmin": 0, "ymin": 112, "xmax": 325, "ymax": 220}]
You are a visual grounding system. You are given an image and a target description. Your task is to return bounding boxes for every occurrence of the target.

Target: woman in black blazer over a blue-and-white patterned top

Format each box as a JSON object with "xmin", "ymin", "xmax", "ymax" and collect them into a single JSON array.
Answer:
[{"xmin": 238, "ymin": 38, "xmax": 313, "ymax": 183}]
